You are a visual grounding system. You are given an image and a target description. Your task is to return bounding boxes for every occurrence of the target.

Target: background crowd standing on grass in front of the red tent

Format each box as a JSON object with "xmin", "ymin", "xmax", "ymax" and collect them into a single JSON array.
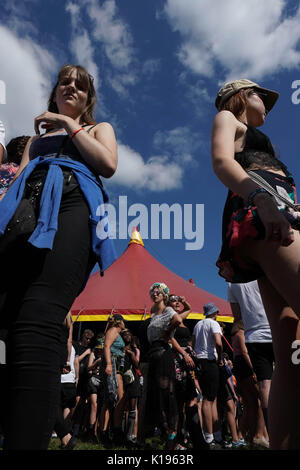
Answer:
[{"xmin": 26, "ymin": 282, "xmax": 273, "ymax": 451}]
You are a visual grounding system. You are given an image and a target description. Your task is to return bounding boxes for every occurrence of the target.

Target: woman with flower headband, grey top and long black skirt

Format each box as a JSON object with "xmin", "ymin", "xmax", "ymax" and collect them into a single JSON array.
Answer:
[{"xmin": 146, "ymin": 282, "xmax": 182, "ymax": 450}]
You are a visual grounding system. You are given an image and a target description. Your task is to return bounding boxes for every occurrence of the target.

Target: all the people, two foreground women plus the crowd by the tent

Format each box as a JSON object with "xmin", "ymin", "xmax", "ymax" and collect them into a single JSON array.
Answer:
[{"xmin": 0, "ymin": 64, "xmax": 300, "ymax": 450}]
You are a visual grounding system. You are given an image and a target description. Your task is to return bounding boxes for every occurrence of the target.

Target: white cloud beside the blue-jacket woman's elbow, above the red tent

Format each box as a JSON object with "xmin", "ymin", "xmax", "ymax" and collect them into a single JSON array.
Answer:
[{"xmin": 111, "ymin": 143, "xmax": 183, "ymax": 191}]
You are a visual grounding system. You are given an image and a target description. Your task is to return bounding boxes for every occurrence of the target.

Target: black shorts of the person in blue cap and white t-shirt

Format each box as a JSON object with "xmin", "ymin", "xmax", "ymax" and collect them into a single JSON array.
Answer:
[{"xmin": 198, "ymin": 359, "xmax": 220, "ymax": 401}]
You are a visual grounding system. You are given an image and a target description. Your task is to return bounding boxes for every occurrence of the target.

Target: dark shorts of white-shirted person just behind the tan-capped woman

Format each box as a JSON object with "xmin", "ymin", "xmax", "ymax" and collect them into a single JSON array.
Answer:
[{"xmin": 246, "ymin": 343, "xmax": 274, "ymax": 382}]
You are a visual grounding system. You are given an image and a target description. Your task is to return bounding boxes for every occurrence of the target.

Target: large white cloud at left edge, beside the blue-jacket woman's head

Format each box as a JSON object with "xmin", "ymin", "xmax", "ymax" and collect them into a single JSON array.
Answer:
[{"xmin": 0, "ymin": 25, "xmax": 58, "ymax": 140}]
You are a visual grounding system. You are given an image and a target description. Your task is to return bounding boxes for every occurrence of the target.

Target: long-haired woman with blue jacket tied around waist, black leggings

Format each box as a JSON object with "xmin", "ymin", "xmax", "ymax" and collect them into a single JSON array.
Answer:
[{"xmin": 0, "ymin": 65, "xmax": 117, "ymax": 450}]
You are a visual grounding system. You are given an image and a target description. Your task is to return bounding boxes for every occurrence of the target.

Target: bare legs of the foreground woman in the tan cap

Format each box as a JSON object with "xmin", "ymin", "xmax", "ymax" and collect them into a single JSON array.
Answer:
[{"xmin": 243, "ymin": 232, "xmax": 300, "ymax": 450}]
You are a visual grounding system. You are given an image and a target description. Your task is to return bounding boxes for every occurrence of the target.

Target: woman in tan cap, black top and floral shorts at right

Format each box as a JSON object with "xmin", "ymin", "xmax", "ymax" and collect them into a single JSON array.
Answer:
[{"xmin": 212, "ymin": 79, "xmax": 300, "ymax": 449}]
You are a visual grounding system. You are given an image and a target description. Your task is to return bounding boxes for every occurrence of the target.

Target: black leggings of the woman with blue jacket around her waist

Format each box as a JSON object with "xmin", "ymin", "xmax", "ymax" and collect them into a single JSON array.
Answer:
[{"xmin": 0, "ymin": 187, "xmax": 95, "ymax": 450}]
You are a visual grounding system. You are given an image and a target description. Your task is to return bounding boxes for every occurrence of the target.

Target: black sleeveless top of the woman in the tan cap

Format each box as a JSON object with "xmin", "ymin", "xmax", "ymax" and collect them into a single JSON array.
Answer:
[{"xmin": 234, "ymin": 125, "xmax": 288, "ymax": 174}]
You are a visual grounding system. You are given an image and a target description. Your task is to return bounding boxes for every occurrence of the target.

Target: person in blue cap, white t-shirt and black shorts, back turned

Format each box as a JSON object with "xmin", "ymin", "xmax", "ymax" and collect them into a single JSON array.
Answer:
[{"xmin": 193, "ymin": 302, "xmax": 223, "ymax": 445}]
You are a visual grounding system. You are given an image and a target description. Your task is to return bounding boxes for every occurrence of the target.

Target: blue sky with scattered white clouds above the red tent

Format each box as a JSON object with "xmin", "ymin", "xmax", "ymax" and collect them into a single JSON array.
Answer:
[{"xmin": 0, "ymin": 0, "xmax": 300, "ymax": 298}]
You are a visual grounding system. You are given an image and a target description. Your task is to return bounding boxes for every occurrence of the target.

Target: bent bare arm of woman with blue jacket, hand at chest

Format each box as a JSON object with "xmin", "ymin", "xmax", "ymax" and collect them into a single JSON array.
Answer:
[{"xmin": 34, "ymin": 111, "xmax": 118, "ymax": 178}]
